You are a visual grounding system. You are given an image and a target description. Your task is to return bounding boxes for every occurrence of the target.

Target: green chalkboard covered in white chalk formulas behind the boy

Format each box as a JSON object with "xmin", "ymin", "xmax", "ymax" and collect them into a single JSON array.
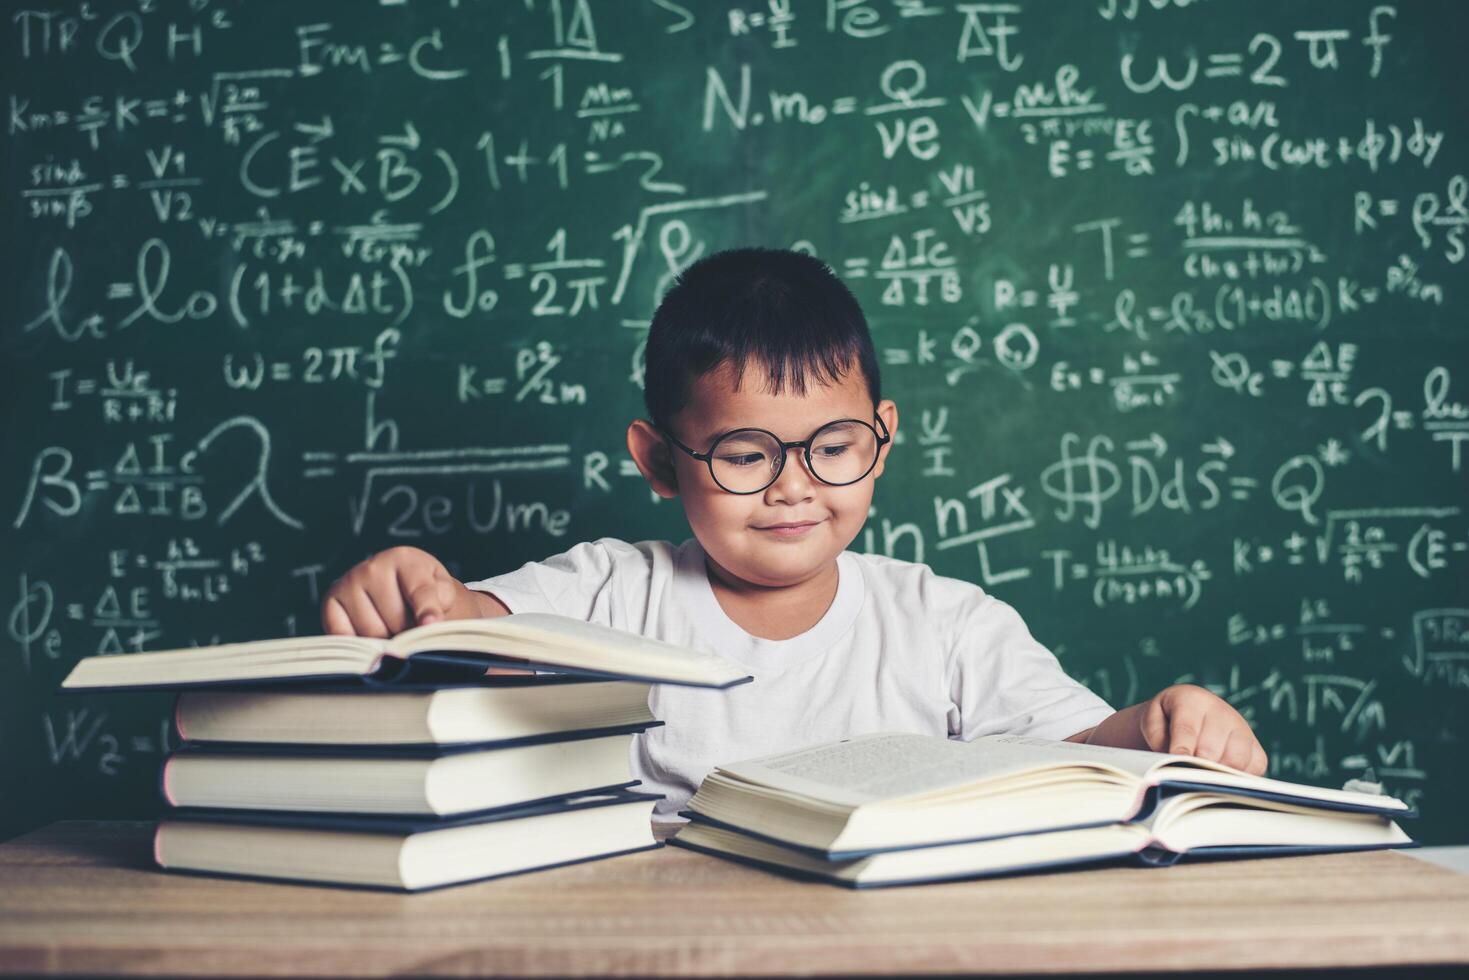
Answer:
[{"xmin": 0, "ymin": 0, "xmax": 1469, "ymax": 842}]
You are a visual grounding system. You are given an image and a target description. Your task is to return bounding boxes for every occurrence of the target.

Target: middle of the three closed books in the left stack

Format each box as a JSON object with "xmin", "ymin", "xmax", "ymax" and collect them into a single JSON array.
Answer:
[{"xmin": 162, "ymin": 721, "xmax": 661, "ymax": 815}]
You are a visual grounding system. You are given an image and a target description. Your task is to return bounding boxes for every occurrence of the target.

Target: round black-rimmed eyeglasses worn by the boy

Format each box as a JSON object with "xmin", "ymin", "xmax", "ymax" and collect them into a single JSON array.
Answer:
[{"xmin": 658, "ymin": 416, "xmax": 892, "ymax": 494}]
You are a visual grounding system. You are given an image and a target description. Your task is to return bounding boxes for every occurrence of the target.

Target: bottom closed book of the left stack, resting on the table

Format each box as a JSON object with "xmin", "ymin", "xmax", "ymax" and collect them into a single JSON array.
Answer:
[{"xmin": 153, "ymin": 790, "xmax": 661, "ymax": 892}]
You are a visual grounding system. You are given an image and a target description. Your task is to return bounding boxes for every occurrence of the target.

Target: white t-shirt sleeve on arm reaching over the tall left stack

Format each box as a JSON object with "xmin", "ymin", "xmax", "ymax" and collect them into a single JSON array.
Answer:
[{"xmin": 464, "ymin": 538, "xmax": 646, "ymax": 626}]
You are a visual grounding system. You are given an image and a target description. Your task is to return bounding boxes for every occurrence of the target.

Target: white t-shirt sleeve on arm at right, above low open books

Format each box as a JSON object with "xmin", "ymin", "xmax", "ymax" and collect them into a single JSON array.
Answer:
[{"xmin": 949, "ymin": 595, "xmax": 1112, "ymax": 742}]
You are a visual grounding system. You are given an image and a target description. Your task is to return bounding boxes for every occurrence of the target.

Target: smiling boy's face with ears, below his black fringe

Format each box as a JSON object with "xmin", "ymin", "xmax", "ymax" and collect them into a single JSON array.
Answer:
[{"xmin": 629, "ymin": 363, "xmax": 898, "ymax": 588}]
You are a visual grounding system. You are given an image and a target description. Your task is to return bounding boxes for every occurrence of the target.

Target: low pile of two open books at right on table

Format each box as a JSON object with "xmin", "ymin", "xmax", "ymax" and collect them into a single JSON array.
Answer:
[{"xmin": 673, "ymin": 733, "xmax": 1416, "ymax": 887}]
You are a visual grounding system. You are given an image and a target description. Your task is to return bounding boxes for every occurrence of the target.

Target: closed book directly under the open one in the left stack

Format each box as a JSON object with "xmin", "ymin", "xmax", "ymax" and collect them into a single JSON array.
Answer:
[{"xmin": 173, "ymin": 674, "xmax": 654, "ymax": 745}]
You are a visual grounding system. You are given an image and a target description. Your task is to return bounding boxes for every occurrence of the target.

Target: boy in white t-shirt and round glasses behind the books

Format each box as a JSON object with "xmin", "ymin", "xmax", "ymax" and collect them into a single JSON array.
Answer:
[{"xmin": 322, "ymin": 248, "xmax": 1265, "ymax": 820}]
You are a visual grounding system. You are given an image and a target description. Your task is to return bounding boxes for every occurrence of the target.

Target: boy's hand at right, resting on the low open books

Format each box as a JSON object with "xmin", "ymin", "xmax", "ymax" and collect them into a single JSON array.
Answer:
[{"xmin": 1138, "ymin": 685, "xmax": 1266, "ymax": 776}]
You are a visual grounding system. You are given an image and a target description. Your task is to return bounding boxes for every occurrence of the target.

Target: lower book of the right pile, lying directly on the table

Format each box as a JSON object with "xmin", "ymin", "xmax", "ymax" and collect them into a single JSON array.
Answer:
[{"xmin": 671, "ymin": 790, "xmax": 1415, "ymax": 887}]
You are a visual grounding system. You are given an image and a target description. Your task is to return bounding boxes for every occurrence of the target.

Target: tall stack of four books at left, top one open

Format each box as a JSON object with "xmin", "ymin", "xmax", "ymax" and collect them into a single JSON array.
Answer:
[{"xmin": 62, "ymin": 613, "xmax": 749, "ymax": 890}]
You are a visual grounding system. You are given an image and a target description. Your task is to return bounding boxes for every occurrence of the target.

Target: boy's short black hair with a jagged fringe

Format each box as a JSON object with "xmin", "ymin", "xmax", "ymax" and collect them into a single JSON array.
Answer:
[{"xmin": 643, "ymin": 248, "xmax": 881, "ymax": 426}]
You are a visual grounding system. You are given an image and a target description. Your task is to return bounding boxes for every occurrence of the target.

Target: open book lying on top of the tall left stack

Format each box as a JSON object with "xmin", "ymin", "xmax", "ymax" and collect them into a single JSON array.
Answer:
[{"xmin": 62, "ymin": 613, "xmax": 751, "ymax": 691}]
